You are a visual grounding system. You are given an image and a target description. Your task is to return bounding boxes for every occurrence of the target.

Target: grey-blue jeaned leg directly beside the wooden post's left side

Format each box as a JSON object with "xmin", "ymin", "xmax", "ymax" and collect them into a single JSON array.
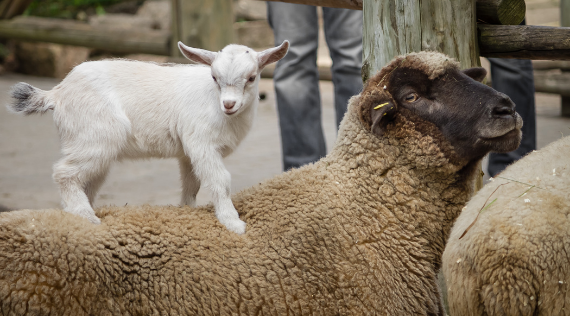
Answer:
[{"xmin": 323, "ymin": 8, "xmax": 362, "ymax": 128}]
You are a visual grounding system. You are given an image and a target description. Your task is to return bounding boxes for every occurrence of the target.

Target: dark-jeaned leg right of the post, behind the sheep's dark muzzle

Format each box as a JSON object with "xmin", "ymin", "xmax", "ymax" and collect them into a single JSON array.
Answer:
[{"xmin": 487, "ymin": 58, "xmax": 536, "ymax": 177}]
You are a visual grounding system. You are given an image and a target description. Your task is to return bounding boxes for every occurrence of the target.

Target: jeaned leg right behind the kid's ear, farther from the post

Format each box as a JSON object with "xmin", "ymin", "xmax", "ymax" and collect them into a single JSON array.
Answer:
[{"xmin": 267, "ymin": 2, "xmax": 326, "ymax": 170}]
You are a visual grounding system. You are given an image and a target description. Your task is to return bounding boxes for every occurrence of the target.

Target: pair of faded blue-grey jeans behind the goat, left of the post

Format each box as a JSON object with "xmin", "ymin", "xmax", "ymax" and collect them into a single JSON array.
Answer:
[{"xmin": 267, "ymin": 2, "xmax": 362, "ymax": 170}]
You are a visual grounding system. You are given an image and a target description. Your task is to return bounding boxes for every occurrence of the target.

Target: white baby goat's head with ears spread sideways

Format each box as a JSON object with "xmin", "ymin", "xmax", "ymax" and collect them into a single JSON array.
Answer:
[{"xmin": 178, "ymin": 41, "xmax": 289, "ymax": 115}]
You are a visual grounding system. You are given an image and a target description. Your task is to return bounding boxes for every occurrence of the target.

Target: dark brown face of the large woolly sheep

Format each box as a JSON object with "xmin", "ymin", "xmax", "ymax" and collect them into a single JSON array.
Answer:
[{"xmin": 370, "ymin": 67, "xmax": 522, "ymax": 160}]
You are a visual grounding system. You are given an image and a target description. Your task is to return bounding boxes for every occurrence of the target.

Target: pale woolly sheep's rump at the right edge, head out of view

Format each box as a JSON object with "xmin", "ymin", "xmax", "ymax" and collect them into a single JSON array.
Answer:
[{"xmin": 442, "ymin": 137, "xmax": 570, "ymax": 315}]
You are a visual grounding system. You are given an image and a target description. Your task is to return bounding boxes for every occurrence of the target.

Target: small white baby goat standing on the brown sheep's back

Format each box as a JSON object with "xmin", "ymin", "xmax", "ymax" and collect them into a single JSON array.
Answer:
[{"xmin": 4, "ymin": 41, "xmax": 289, "ymax": 234}]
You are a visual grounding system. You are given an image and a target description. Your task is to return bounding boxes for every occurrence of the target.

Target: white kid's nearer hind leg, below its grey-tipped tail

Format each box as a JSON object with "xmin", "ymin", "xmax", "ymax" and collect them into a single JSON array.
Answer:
[{"xmin": 53, "ymin": 156, "xmax": 108, "ymax": 224}]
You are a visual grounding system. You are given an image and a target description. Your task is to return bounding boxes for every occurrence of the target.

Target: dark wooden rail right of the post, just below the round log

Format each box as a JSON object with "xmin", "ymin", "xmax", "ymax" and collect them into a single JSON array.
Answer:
[{"xmin": 478, "ymin": 24, "xmax": 570, "ymax": 60}]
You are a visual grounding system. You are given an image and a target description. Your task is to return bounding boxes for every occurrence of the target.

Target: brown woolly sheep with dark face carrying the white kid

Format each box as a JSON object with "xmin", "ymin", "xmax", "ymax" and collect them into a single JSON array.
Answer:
[{"xmin": 0, "ymin": 52, "xmax": 521, "ymax": 315}]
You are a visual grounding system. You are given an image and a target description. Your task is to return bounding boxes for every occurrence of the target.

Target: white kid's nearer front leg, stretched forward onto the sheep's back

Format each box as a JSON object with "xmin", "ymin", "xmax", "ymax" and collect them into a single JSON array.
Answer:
[{"xmin": 186, "ymin": 147, "xmax": 245, "ymax": 234}]
